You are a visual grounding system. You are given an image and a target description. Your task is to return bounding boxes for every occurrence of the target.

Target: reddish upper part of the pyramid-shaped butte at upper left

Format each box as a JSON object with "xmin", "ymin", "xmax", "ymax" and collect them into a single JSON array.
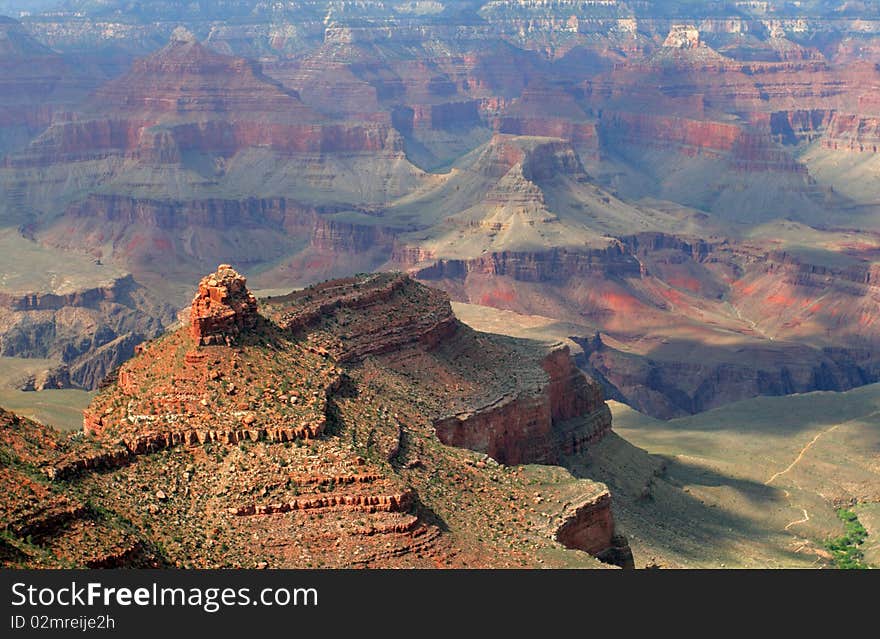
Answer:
[{"xmin": 7, "ymin": 34, "xmax": 402, "ymax": 167}]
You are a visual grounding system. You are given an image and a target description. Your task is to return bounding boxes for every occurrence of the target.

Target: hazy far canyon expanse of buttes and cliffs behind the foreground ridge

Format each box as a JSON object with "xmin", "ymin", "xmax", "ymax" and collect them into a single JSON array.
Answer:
[{"xmin": 0, "ymin": 3, "xmax": 880, "ymax": 416}]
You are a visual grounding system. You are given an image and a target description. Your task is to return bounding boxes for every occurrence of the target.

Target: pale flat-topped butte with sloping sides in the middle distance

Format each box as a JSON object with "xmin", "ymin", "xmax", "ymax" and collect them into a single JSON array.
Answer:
[{"xmin": 390, "ymin": 134, "xmax": 704, "ymax": 266}]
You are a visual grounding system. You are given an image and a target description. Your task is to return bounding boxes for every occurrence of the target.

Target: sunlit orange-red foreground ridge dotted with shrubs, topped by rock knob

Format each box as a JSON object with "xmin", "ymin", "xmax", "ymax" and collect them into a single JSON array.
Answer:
[{"xmin": 0, "ymin": 266, "xmax": 632, "ymax": 567}]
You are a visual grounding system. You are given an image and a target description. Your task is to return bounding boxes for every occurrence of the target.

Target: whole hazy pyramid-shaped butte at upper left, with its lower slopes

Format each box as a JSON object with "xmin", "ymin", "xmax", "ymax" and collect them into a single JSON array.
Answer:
[{"xmin": 0, "ymin": 30, "xmax": 430, "ymax": 290}]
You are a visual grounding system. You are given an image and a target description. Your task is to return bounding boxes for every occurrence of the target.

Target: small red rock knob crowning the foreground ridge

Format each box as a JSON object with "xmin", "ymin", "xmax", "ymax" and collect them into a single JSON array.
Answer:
[{"xmin": 190, "ymin": 264, "xmax": 257, "ymax": 345}]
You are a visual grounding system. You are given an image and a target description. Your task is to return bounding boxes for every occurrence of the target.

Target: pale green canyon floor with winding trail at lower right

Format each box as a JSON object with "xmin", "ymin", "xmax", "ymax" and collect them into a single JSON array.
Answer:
[{"xmin": 608, "ymin": 384, "xmax": 880, "ymax": 568}]
